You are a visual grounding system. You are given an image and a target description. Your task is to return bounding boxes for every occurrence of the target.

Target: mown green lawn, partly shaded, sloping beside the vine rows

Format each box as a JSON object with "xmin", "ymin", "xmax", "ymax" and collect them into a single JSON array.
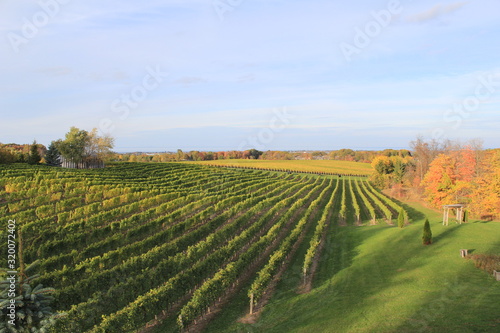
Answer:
[{"xmin": 208, "ymin": 201, "xmax": 500, "ymax": 332}]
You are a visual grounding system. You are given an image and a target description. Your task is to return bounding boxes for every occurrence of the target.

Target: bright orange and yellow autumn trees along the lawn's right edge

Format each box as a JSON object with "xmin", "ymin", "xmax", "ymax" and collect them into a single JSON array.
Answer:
[{"xmin": 370, "ymin": 137, "xmax": 500, "ymax": 219}]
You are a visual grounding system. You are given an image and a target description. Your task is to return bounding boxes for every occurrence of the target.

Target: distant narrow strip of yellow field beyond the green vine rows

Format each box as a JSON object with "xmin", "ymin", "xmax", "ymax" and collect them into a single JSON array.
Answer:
[{"xmin": 188, "ymin": 160, "xmax": 372, "ymax": 175}]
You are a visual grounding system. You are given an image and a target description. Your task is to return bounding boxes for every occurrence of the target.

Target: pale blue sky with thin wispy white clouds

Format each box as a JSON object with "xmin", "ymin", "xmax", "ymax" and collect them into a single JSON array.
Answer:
[{"xmin": 0, "ymin": 0, "xmax": 500, "ymax": 152}]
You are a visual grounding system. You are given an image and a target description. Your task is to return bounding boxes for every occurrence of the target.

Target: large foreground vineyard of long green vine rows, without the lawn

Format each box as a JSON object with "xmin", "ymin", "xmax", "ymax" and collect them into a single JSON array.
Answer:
[{"xmin": 0, "ymin": 163, "xmax": 408, "ymax": 332}]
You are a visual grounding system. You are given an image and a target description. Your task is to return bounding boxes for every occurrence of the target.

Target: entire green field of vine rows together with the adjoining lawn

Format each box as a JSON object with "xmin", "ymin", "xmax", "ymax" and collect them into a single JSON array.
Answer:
[{"xmin": 0, "ymin": 161, "xmax": 500, "ymax": 332}]
